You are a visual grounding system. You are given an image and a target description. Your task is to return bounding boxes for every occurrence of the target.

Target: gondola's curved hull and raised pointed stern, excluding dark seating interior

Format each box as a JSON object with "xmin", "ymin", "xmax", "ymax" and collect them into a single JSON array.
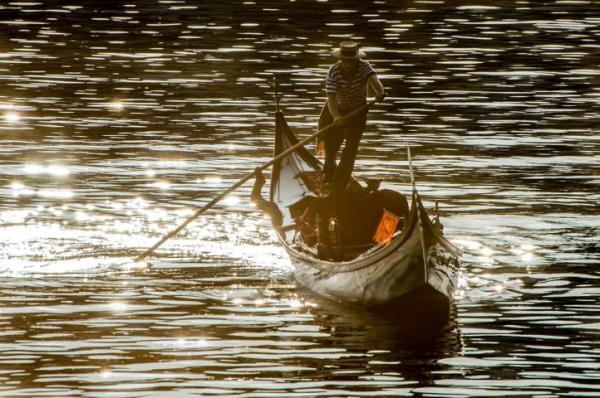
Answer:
[{"xmin": 269, "ymin": 105, "xmax": 460, "ymax": 308}]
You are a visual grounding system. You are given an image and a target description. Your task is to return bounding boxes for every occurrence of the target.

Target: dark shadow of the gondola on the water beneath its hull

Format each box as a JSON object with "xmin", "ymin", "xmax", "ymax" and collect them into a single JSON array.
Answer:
[{"xmin": 299, "ymin": 288, "xmax": 463, "ymax": 384}]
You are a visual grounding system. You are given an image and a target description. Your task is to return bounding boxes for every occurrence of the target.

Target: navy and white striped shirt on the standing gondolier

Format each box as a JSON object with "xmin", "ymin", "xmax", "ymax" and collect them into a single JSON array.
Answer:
[{"xmin": 325, "ymin": 60, "xmax": 375, "ymax": 110}]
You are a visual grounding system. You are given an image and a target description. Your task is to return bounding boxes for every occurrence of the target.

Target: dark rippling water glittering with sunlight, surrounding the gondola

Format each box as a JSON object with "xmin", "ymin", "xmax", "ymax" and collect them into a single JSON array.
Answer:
[{"xmin": 0, "ymin": 0, "xmax": 600, "ymax": 397}]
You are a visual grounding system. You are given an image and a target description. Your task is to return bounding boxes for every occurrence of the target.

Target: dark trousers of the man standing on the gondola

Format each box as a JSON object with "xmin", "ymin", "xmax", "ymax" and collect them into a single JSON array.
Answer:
[{"xmin": 318, "ymin": 103, "xmax": 367, "ymax": 186}]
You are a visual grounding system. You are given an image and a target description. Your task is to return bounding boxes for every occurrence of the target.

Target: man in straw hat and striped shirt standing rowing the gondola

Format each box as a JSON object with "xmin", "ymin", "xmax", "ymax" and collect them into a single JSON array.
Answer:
[{"xmin": 318, "ymin": 41, "xmax": 385, "ymax": 188}]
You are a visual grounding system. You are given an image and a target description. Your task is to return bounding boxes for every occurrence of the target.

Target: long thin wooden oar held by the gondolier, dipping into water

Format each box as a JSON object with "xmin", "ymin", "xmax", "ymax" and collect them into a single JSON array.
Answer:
[{"xmin": 135, "ymin": 100, "xmax": 375, "ymax": 262}]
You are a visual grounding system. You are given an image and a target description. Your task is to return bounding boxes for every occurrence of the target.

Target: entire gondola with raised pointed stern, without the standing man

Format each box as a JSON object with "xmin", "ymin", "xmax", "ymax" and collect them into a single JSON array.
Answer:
[{"xmin": 262, "ymin": 103, "xmax": 460, "ymax": 307}]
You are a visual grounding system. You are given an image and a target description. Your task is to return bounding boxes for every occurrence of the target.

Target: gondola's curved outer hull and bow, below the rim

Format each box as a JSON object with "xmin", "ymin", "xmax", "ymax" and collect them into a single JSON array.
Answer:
[{"xmin": 282, "ymin": 194, "xmax": 458, "ymax": 307}]
